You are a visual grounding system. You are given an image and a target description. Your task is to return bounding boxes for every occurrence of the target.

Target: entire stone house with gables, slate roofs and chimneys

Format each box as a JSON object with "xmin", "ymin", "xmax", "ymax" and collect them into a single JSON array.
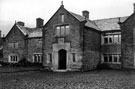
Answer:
[{"xmin": 3, "ymin": 4, "xmax": 135, "ymax": 71}]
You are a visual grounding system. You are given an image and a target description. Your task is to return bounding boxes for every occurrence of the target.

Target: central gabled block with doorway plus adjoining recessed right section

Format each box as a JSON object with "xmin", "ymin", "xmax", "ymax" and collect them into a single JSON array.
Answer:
[{"xmin": 43, "ymin": 5, "xmax": 127, "ymax": 71}]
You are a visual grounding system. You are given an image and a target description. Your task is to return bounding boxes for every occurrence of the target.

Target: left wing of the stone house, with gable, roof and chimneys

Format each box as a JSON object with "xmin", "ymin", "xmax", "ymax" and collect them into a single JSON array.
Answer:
[{"xmin": 3, "ymin": 18, "xmax": 43, "ymax": 63}]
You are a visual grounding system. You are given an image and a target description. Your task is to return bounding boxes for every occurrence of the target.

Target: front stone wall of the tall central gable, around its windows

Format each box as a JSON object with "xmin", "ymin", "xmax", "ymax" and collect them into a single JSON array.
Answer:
[{"xmin": 43, "ymin": 7, "xmax": 82, "ymax": 68}]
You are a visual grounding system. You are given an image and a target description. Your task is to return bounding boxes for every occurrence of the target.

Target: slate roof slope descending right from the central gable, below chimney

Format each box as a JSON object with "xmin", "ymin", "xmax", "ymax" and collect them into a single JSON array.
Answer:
[{"xmin": 69, "ymin": 11, "xmax": 100, "ymax": 30}]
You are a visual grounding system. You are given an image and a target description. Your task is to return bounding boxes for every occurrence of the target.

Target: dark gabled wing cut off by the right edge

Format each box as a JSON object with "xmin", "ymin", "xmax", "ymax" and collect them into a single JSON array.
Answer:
[{"xmin": 119, "ymin": 4, "xmax": 135, "ymax": 68}]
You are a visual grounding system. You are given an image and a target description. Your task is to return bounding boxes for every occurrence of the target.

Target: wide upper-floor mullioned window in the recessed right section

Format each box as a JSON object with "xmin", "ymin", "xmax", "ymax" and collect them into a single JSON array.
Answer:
[{"xmin": 104, "ymin": 34, "xmax": 121, "ymax": 44}]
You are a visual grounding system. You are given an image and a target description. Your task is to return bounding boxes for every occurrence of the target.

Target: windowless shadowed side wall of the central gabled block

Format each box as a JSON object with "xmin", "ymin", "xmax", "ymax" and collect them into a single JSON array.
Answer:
[{"xmin": 82, "ymin": 28, "xmax": 101, "ymax": 70}]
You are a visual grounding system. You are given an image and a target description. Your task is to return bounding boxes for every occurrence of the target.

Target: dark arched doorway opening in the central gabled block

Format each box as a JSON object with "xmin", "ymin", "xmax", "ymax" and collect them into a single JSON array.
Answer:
[{"xmin": 58, "ymin": 49, "xmax": 67, "ymax": 69}]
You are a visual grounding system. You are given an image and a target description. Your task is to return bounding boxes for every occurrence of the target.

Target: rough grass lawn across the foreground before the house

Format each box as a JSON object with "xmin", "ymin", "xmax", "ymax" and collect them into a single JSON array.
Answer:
[{"xmin": 0, "ymin": 70, "xmax": 135, "ymax": 89}]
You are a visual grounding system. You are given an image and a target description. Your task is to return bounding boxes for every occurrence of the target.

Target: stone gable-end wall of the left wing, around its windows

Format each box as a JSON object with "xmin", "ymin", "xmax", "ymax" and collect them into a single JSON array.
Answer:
[{"xmin": 3, "ymin": 25, "xmax": 27, "ymax": 62}]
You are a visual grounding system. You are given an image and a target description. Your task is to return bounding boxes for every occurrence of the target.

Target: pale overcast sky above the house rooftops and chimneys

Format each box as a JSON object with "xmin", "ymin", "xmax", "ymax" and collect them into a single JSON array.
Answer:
[{"xmin": 0, "ymin": 0, "xmax": 135, "ymax": 35}]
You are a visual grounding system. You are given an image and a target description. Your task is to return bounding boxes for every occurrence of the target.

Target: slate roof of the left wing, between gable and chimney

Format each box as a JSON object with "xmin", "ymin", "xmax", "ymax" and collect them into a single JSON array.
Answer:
[{"xmin": 16, "ymin": 24, "xmax": 42, "ymax": 38}]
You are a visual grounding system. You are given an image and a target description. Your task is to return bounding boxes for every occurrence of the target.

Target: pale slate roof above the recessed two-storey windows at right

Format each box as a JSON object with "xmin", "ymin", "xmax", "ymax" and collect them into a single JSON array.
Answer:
[{"xmin": 94, "ymin": 16, "xmax": 128, "ymax": 31}]
